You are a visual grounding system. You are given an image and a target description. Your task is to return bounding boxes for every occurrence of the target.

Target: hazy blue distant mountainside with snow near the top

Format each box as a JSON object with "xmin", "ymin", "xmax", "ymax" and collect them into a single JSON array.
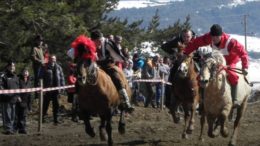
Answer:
[{"xmin": 109, "ymin": 0, "xmax": 260, "ymax": 37}]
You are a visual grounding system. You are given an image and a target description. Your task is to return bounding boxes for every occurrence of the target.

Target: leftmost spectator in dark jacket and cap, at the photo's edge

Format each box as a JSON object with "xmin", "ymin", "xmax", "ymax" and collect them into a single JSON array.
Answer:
[{"xmin": 0, "ymin": 61, "xmax": 20, "ymax": 135}]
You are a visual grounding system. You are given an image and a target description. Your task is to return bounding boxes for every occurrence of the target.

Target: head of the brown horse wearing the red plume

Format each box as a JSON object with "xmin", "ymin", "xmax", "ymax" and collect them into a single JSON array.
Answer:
[{"xmin": 79, "ymin": 59, "xmax": 98, "ymax": 84}]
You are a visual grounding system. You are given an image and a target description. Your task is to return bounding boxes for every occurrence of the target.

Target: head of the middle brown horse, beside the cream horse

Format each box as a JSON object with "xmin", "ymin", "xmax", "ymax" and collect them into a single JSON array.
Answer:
[{"xmin": 177, "ymin": 55, "xmax": 193, "ymax": 78}]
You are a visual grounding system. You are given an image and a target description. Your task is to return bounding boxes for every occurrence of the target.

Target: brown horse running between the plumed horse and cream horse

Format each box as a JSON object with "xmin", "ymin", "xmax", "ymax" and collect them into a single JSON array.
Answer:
[{"xmin": 170, "ymin": 55, "xmax": 200, "ymax": 138}]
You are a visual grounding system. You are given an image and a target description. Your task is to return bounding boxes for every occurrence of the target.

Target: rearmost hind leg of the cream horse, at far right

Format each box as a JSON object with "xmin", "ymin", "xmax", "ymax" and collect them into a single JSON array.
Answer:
[{"xmin": 229, "ymin": 98, "xmax": 247, "ymax": 146}]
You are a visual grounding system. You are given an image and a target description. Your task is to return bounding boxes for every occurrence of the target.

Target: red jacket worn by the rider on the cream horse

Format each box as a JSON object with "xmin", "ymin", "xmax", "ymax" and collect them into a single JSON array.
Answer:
[{"xmin": 184, "ymin": 33, "xmax": 248, "ymax": 68}]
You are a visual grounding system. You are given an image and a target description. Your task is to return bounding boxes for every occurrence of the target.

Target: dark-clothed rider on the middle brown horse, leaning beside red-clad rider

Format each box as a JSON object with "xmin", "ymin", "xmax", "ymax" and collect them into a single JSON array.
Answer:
[{"xmin": 161, "ymin": 29, "xmax": 195, "ymax": 107}]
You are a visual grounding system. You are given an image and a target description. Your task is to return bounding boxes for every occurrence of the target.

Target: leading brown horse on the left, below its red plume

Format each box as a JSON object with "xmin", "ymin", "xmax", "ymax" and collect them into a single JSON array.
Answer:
[{"xmin": 78, "ymin": 60, "xmax": 130, "ymax": 146}]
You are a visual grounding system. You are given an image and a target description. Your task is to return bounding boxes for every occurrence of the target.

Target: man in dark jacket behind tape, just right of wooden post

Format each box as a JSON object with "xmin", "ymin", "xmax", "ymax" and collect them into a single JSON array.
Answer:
[{"xmin": 41, "ymin": 55, "xmax": 65, "ymax": 124}]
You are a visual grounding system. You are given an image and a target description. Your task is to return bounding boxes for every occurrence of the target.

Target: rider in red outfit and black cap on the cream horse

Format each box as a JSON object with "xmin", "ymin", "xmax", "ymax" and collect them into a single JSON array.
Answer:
[{"xmin": 184, "ymin": 24, "xmax": 248, "ymax": 107}]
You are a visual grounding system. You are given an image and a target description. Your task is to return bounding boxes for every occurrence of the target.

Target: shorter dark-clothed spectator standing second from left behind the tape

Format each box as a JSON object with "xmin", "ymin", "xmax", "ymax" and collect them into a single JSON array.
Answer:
[{"xmin": 15, "ymin": 68, "xmax": 32, "ymax": 134}]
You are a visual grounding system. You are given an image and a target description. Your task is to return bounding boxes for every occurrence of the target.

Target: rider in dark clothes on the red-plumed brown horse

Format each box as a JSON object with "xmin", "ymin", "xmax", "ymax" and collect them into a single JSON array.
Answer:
[{"xmin": 91, "ymin": 30, "xmax": 134, "ymax": 112}]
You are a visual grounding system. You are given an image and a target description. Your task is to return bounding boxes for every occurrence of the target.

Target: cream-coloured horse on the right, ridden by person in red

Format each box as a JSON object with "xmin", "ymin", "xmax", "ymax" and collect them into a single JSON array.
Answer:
[{"xmin": 199, "ymin": 46, "xmax": 251, "ymax": 146}]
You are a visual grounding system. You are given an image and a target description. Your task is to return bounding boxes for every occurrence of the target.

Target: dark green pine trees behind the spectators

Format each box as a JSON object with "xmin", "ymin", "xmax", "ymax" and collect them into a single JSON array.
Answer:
[{"xmin": 0, "ymin": 0, "xmax": 191, "ymax": 70}]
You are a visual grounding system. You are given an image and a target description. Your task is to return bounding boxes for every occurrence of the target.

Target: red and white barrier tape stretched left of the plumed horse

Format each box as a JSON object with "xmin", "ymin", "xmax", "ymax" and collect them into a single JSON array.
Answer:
[{"xmin": 0, "ymin": 85, "xmax": 75, "ymax": 94}]
